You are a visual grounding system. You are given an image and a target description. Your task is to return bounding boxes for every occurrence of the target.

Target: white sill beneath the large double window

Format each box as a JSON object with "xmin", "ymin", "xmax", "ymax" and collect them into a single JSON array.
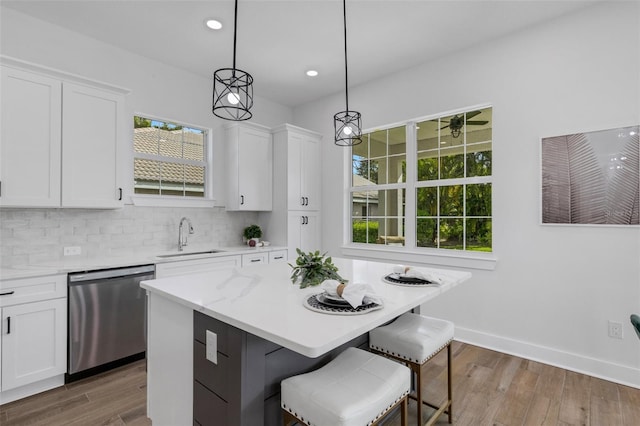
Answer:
[{"xmin": 342, "ymin": 244, "xmax": 498, "ymax": 271}]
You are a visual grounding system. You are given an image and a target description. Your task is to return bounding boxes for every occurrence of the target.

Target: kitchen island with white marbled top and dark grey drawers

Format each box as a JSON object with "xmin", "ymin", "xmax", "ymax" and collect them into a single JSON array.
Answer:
[{"xmin": 141, "ymin": 258, "xmax": 471, "ymax": 426}]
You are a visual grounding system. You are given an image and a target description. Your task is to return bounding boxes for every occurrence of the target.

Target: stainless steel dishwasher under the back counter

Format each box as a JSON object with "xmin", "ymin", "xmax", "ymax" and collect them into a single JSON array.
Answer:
[{"xmin": 66, "ymin": 265, "xmax": 155, "ymax": 382}]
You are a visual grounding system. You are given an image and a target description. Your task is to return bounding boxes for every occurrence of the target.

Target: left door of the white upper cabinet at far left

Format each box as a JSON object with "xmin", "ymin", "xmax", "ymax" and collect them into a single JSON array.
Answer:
[{"xmin": 0, "ymin": 67, "xmax": 62, "ymax": 207}]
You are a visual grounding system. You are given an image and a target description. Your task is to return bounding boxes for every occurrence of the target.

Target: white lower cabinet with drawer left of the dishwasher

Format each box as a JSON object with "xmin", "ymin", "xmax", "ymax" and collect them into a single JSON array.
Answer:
[{"xmin": 0, "ymin": 275, "xmax": 67, "ymax": 403}]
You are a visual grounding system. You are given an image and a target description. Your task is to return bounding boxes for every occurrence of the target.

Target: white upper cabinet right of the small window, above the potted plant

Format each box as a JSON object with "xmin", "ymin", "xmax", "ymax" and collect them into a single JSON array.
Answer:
[{"xmin": 223, "ymin": 123, "xmax": 273, "ymax": 211}]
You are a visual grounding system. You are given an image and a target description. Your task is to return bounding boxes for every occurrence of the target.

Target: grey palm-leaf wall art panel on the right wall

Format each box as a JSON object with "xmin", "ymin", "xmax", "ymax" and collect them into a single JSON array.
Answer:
[{"xmin": 542, "ymin": 126, "xmax": 640, "ymax": 225}]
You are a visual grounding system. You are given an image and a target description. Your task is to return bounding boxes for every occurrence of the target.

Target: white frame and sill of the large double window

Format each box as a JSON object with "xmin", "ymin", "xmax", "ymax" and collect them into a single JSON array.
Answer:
[{"xmin": 342, "ymin": 104, "xmax": 497, "ymax": 270}]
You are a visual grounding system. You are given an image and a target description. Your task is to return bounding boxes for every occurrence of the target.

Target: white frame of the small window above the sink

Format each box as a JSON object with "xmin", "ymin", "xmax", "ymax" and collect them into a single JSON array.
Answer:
[{"xmin": 129, "ymin": 112, "xmax": 216, "ymax": 208}]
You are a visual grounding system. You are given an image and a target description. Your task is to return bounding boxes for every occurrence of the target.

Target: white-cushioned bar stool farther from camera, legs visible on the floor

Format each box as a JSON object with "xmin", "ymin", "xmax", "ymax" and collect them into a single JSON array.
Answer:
[{"xmin": 369, "ymin": 313, "xmax": 454, "ymax": 425}]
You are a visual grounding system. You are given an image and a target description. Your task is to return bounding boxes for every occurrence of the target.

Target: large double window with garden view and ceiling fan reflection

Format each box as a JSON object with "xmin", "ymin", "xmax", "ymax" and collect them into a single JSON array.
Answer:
[{"xmin": 350, "ymin": 107, "xmax": 492, "ymax": 252}]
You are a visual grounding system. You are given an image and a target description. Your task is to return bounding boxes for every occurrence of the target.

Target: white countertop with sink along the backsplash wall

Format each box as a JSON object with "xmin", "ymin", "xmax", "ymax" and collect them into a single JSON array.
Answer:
[{"xmin": 0, "ymin": 244, "xmax": 287, "ymax": 280}]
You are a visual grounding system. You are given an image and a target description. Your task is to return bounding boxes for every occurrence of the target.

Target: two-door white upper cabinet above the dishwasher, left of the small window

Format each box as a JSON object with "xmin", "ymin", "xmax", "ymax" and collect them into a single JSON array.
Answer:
[{"xmin": 0, "ymin": 62, "xmax": 127, "ymax": 208}]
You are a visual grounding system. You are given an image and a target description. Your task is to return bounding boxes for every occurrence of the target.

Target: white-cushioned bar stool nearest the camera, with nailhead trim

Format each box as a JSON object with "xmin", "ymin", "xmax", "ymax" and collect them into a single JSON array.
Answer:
[{"xmin": 280, "ymin": 348, "xmax": 411, "ymax": 426}]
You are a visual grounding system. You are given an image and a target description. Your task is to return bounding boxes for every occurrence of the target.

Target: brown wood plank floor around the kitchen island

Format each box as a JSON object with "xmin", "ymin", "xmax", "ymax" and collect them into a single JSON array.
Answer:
[{"xmin": 0, "ymin": 342, "xmax": 640, "ymax": 426}]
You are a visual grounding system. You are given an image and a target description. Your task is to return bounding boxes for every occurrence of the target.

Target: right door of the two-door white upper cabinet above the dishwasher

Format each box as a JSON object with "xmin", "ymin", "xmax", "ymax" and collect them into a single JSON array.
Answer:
[{"xmin": 62, "ymin": 83, "xmax": 126, "ymax": 208}]
